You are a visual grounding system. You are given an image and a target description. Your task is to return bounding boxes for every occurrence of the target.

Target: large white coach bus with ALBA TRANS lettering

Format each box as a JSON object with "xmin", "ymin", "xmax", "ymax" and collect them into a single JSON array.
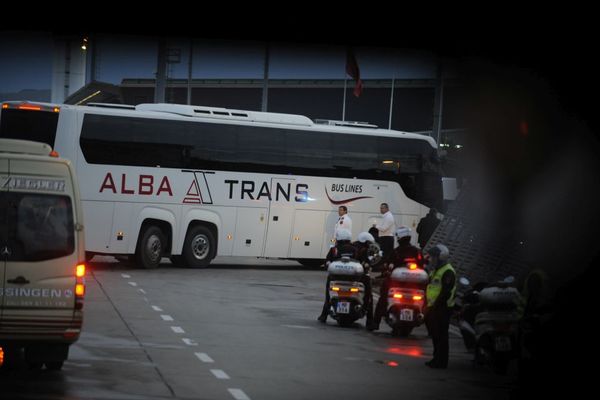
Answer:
[{"xmin": 0, "ymin": 101, "xmax": 442, "ymax": 268}]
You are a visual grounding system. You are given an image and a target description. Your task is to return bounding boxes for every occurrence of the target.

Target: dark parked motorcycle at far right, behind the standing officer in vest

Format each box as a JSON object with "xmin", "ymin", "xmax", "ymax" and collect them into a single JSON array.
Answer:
[{"xmin": 459, "ymin": 276, "xmax": 520, "ymax": 374}]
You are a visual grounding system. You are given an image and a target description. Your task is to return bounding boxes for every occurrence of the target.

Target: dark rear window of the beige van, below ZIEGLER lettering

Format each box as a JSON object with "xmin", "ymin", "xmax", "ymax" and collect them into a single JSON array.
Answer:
[{"xmin": 0, "ymin": 192, "xmax": 75, "ymax": 261}]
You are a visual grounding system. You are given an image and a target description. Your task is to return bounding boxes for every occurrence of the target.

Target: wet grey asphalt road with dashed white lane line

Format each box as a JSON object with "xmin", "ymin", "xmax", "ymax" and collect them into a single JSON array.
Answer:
[{"xmin": 0, "ymin": 257, "xmax": 515, "ymax": 400}]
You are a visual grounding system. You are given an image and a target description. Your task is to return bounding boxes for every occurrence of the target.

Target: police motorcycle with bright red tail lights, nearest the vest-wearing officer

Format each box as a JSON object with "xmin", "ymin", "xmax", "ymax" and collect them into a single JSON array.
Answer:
[{"xmin": 385, "ymin": 258, "xmax": 429, "ymax": 336}]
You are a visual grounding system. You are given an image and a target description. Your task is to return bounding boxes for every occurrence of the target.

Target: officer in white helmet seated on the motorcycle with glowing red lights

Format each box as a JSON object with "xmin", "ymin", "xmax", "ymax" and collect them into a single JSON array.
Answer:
[{"xmin": 367, "ymin": 226, "xmax": 423, "ymax": 331}]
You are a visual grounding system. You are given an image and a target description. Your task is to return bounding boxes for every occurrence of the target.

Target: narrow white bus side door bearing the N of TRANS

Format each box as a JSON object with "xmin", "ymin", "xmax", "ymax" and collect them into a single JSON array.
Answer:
[{"xmin": 264, "ymin": 178, "xmax": 295, "ymax": 258}]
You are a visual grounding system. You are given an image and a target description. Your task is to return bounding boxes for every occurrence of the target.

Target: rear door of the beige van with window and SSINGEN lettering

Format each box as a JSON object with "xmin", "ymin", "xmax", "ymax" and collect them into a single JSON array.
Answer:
[{"xmin": 2, "ymin": 158, "xmax": 79, "ymax": 336}]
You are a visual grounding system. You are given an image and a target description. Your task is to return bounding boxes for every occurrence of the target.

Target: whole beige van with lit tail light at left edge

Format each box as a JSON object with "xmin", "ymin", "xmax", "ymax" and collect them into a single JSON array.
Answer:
[{"xmin": 0, "ymin": 139, "xmax": 85, "ymax": 370}]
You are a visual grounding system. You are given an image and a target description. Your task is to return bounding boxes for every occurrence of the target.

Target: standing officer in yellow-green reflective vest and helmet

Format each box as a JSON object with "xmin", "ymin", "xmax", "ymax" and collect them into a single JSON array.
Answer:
[{"xmin": 425, "ymin": 244, "xmax": 456, "ymax": 368}]
